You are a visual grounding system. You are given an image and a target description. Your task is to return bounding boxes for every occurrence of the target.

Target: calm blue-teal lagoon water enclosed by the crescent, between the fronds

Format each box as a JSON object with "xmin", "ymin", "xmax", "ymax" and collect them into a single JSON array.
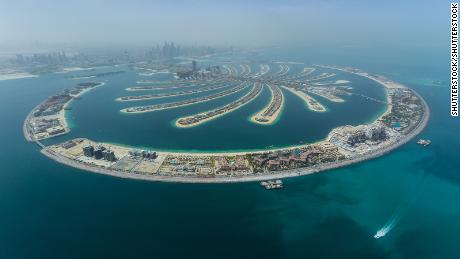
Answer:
[{"xmin": 47, "ymin": 62, "xmax": 385, "ymax": 152}]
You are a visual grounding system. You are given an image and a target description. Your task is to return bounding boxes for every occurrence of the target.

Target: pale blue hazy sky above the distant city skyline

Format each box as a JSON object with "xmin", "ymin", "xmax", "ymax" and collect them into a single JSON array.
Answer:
[{"xmin": 0, "ymin": 0, "xmax": 450, "ymax": 49}]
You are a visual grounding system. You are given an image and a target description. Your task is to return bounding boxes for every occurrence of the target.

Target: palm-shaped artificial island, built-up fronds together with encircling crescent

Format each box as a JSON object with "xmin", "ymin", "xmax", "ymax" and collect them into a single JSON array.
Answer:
[{"xmin": 24, "ymin": 64, "xmax": 425, "ymax": 183}]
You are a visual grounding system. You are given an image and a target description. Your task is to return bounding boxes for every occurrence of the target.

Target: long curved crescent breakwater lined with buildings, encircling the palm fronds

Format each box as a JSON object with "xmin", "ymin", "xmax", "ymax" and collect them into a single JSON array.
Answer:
[{"xmin": 23, "ymin": 66, "xmax": 430, "ymax": 183}]
